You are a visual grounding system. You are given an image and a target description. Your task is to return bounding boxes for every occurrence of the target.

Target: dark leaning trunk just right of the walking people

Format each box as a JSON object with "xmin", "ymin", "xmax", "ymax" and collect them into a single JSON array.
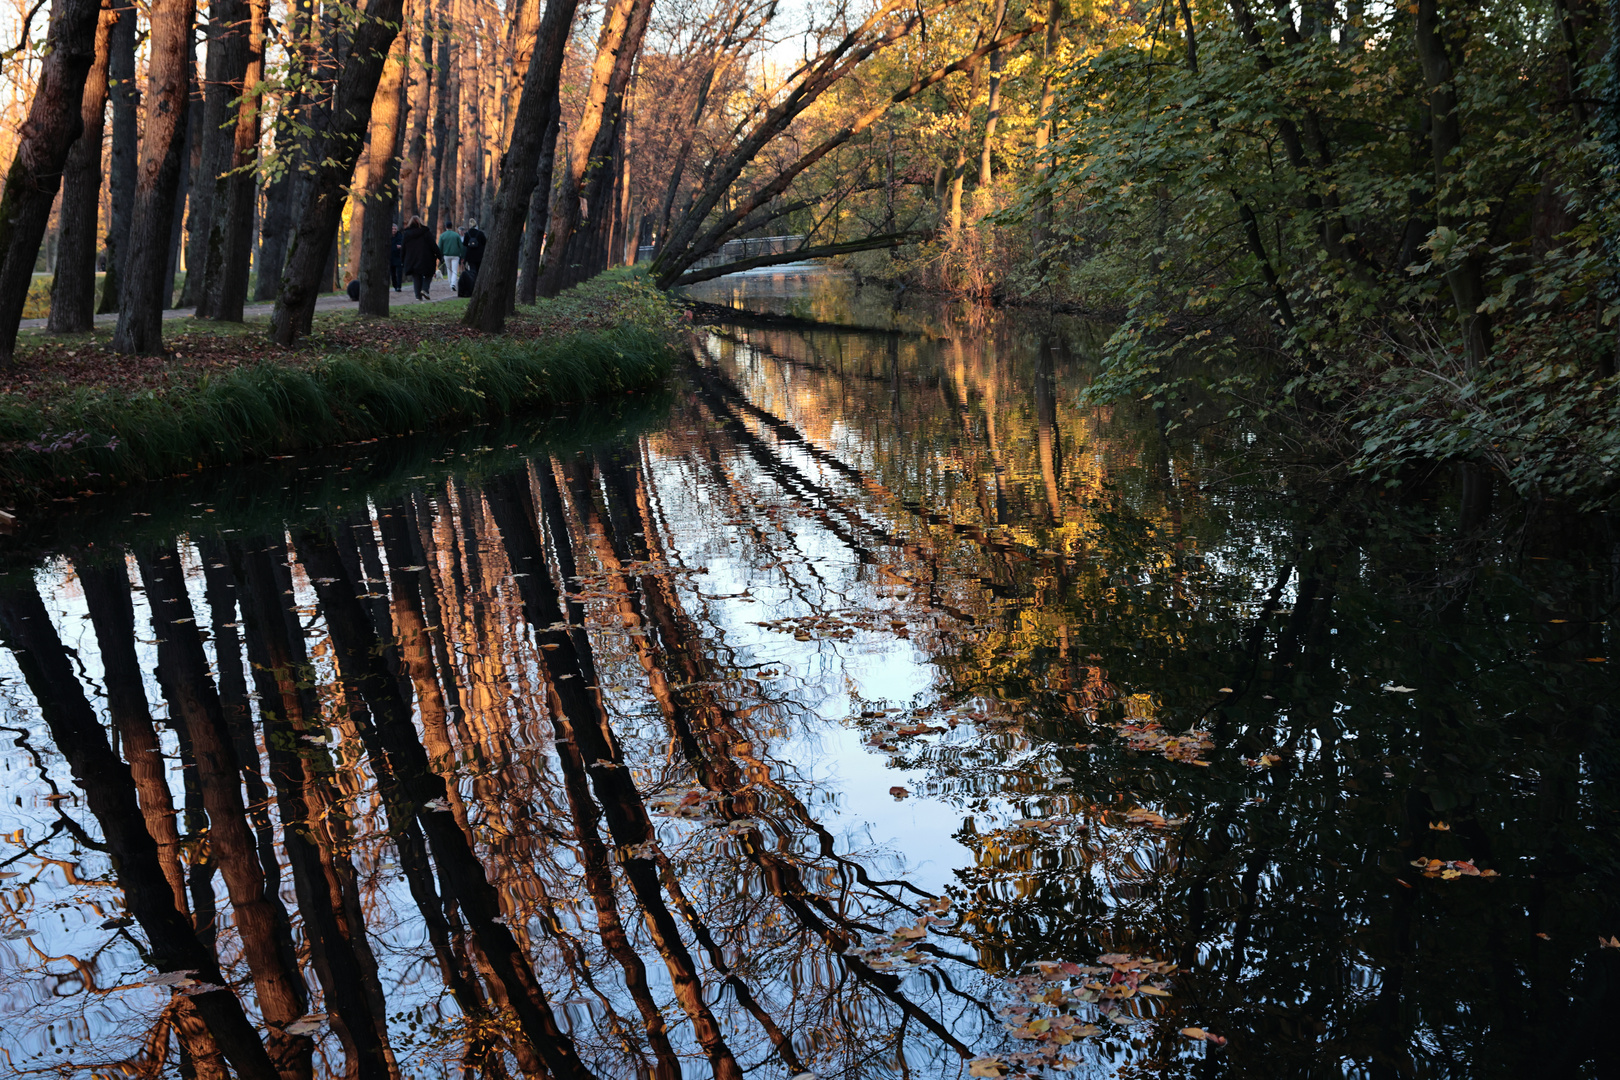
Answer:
[{"xmin": 465, "ymin": 0, "xmax": 578, "ymax": 334}]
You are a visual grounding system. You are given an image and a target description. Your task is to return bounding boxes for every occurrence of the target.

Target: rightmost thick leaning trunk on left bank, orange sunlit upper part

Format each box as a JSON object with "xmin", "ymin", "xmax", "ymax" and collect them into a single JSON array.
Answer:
[{"xmin": 539, "ymin": 0, "xmax": 653, "ymax": 296}]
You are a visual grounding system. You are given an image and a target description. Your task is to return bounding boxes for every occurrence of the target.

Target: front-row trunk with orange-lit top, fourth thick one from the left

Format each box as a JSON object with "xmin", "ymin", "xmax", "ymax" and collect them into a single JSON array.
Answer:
[{"xmin": 198, "ymin": 0, "xmax": 269, "ymax": 322}]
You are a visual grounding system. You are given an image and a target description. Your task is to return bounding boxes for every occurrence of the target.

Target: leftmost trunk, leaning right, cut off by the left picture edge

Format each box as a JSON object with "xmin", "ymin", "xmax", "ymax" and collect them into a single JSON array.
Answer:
[{"xmin": 0, "ymin": 0, "xmax": 100, "ymax": 368}]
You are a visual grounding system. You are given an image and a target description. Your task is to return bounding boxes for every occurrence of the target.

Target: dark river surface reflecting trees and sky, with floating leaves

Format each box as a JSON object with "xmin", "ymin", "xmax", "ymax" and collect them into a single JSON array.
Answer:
[{"xmin": 0, "ymin": 263, "xmax": 1620, "ymax": 1078}]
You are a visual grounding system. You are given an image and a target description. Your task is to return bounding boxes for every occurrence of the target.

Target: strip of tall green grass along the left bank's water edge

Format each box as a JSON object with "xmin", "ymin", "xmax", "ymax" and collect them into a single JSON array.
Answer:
[{"xmin": 0, "ymin": 327, "xmax": 672, "ymax": 497}]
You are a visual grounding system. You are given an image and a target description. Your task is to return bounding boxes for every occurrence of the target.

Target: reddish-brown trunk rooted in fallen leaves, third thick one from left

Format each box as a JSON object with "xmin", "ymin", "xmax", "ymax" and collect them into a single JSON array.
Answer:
[{"xmin": 112, "ymin": 0, "xmax": 196, "ymax": 355}]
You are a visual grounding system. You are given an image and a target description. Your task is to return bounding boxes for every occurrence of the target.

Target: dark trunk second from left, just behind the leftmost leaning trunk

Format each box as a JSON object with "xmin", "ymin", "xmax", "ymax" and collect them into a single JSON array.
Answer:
[{"xmin": 45, "ymin": 0, "xmax": 118, "ymax": 334}]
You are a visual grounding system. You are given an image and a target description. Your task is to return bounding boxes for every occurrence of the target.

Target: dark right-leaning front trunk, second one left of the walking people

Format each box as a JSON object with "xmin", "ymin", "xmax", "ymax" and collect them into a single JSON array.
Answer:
[{"xmin": 271, "ymin": 0, "xmax": 403, "ymax": 345}]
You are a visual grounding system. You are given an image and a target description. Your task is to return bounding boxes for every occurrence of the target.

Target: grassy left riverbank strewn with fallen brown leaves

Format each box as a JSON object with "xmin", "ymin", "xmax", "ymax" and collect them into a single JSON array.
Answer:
[{"xmin": 0, "ymin": 272, "xmax": 676, "ymax": 508}]
